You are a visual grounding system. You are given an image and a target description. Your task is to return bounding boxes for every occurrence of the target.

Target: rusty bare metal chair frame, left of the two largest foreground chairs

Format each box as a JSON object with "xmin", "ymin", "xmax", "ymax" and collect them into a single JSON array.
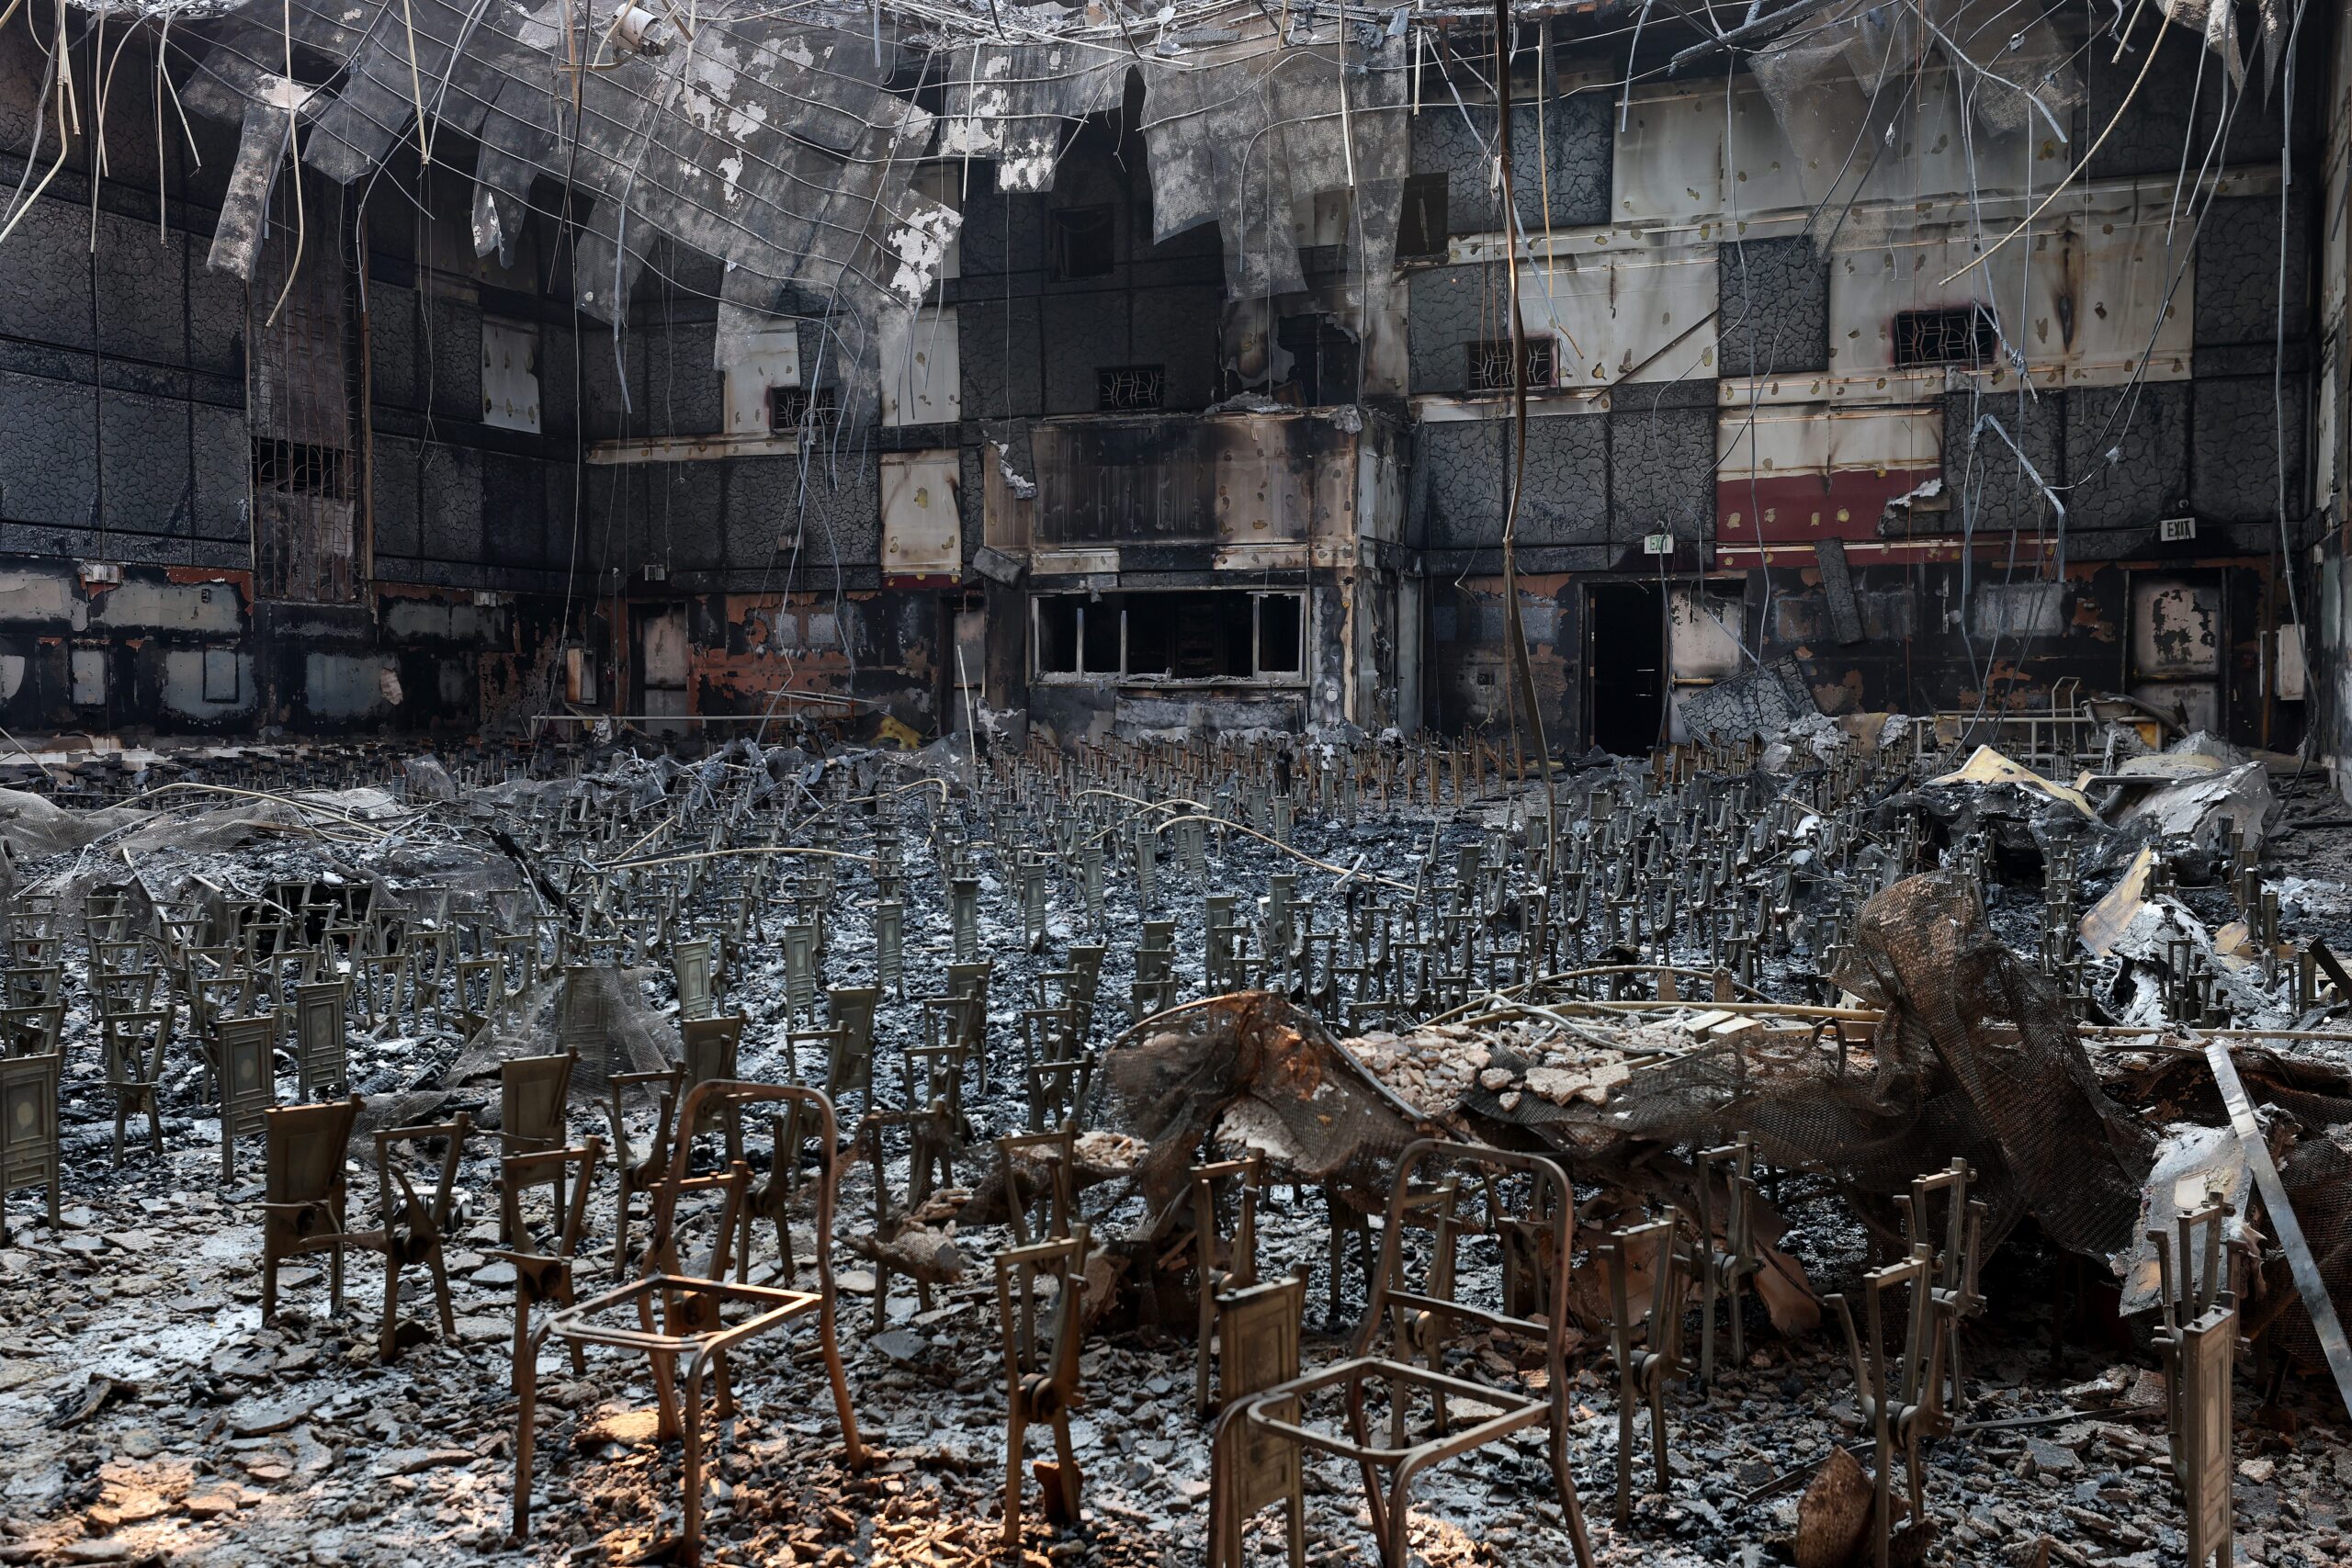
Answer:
[{"xmin": 515, "ymin": 1079, "xmax": 868, "ymax": 1568}]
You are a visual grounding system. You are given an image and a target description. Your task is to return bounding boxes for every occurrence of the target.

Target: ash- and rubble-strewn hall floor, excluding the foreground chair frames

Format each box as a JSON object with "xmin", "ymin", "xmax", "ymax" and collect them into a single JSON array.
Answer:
[{"xmin": 0, "ymin": 719, "xmax": 2352, "ymax": 1568}]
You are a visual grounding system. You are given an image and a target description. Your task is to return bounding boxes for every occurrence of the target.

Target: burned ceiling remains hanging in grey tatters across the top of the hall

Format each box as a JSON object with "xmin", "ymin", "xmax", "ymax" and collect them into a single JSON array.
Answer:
[{"xmin": 9, "ymin": 0, "xmax": 2281, "ymax": 423}]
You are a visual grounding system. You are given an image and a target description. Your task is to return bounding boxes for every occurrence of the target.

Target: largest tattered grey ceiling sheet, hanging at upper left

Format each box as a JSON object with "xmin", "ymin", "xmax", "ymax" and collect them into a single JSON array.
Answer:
[{"xmin": 184, "ymin": 0, "xmax": 959, "ymax": 413}]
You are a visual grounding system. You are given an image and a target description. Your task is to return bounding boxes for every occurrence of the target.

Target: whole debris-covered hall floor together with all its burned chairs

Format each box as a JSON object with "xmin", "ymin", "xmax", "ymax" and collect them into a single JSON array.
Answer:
[{"xmin": 0, "ymin": 728, "xmax": 2352, "ymax": 1568}]
